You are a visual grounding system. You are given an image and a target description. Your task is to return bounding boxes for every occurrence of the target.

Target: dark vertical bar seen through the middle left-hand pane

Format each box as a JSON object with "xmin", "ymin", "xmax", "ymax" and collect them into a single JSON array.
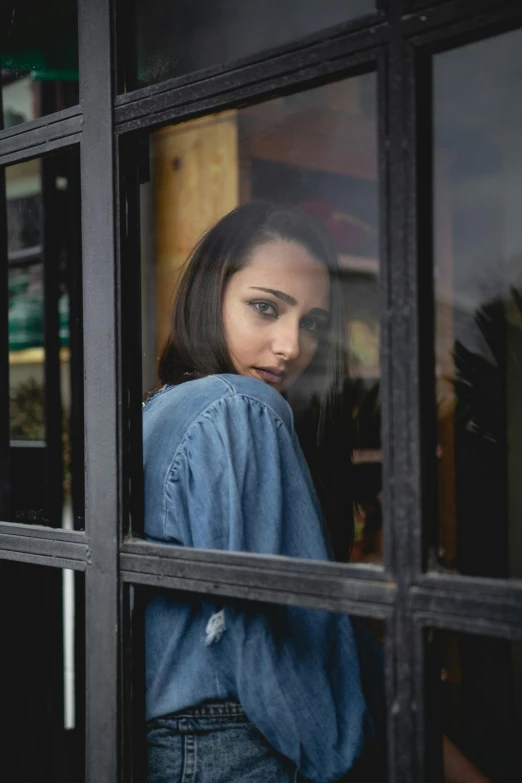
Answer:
[{"xmin": 40, "ymin": 156, "xmax": 63, "ymax": 527}]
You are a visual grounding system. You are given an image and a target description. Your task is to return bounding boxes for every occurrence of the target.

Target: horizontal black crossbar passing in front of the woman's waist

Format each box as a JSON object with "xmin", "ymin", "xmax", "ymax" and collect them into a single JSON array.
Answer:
[{"xmin": 120, "ymin": 540, "xmax": 395, "ymax": 619}]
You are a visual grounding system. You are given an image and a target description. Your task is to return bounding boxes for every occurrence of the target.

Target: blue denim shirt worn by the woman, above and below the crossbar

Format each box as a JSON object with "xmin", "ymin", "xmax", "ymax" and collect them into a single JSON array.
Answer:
[{"xmin": 143, "ymin": 375, "xmax": 380, "ymax": 783}]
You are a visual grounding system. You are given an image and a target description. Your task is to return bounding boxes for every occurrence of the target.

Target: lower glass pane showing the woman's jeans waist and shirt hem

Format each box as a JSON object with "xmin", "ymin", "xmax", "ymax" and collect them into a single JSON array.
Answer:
[{"xmin": 132, "ymin": 590, "xmax": 386, "ymax": 783}]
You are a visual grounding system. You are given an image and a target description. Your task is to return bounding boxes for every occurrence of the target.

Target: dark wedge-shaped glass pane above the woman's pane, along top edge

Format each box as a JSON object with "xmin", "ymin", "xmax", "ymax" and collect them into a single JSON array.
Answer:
[{"xmin": 126, "ymin": 0, "xmax": 375, "ymax": 89}]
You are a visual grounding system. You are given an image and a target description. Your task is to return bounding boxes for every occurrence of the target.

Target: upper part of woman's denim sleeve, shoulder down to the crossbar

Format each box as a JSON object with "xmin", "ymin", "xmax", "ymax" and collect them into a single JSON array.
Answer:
[{"xmin": 164, "ymin": 395, "xmax": 330, "ymax": 560}]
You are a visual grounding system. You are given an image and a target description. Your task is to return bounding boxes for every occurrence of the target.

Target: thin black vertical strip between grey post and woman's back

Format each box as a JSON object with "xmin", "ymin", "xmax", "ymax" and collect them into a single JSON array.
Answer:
[{"xmin": 116, "ymin": 136, "xmax": 144, "ymax": 783}]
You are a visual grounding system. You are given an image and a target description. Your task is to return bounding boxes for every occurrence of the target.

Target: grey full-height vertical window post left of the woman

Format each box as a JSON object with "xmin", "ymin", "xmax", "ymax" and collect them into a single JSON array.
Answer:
[{"xmin": 79, "ymin": 0, "xmax": 119, "ymax": 783}]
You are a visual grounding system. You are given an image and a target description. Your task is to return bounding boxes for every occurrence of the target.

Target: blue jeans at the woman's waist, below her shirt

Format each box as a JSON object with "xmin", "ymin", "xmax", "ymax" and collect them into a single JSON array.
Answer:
[{"xmin": 147, "ymin": 701, "xmax": 306, "ymax": 783}]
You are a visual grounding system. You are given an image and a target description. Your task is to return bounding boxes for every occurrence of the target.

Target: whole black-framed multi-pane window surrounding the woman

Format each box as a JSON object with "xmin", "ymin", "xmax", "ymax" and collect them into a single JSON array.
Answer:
[{"xmin": 0, "ymin": 0, "xmax": 522, "ymax": 783}]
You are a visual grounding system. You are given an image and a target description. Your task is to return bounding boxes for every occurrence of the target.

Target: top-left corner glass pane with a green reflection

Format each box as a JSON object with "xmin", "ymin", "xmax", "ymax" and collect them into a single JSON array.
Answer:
[{"xmin": 0, "ymin": 0, "xmax": 78, "ymax": 128}]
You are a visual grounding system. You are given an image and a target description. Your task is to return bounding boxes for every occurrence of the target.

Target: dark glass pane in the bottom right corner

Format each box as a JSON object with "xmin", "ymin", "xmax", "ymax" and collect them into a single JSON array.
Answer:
[{"xmin": 428, "ymin": 631, "xmax": 522, "ymax": 783}]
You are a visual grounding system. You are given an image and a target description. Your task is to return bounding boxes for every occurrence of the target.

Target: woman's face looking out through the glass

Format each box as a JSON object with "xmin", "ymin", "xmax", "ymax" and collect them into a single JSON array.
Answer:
[{"xmin": 223, "ymin": 240, "xmax": 330, "ymax": 391}]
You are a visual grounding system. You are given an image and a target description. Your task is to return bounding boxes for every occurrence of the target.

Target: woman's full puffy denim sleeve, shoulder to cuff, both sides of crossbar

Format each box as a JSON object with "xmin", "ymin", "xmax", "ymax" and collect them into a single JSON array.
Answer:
[{"xmin": 165, "ymin": 396, "xmax": 373, "ymax": 783}]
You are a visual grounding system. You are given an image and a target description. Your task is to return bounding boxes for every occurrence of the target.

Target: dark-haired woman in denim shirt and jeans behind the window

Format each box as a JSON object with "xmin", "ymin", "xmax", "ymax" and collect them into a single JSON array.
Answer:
[{"xmin": 143, "ymin": 203, "xmax": 488, "ymax": 783}]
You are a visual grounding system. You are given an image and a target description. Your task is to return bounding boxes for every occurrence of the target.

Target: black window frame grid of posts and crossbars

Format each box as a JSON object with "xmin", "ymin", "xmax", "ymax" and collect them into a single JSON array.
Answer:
[{"xmin": 0, "ymin": 0, "xmax": 522, "ymax": 783}]
